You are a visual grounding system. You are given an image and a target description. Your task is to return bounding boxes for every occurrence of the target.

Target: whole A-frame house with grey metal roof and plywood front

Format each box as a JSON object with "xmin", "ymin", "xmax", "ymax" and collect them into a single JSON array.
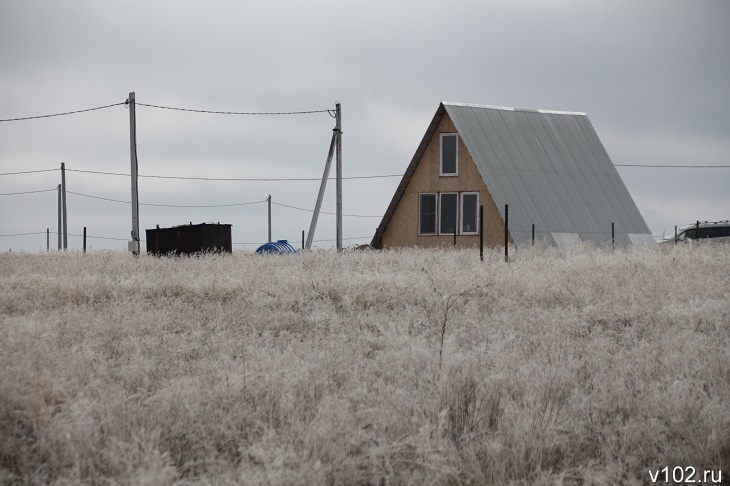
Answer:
[{"xmin": 372, "ymin": 103, "xmax": 654, "ymax": 248}]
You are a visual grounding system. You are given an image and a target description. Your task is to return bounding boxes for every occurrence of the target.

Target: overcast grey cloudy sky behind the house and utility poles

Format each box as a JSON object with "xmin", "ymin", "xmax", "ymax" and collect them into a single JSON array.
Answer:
[{"xmin": 0, "ymin": 0, "xmax": 730, "ymax": 251}]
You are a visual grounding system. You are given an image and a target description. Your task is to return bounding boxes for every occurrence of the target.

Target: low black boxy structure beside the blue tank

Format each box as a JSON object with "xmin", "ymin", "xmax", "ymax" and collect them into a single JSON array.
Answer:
[{"xmin": 146, "ymin": 223, "xmax": 232, "ymax": 255}]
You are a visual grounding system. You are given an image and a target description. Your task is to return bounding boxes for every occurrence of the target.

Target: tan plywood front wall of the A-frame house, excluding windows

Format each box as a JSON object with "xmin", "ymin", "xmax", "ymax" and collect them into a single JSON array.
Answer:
[{"xmin": 383, "ymin": 114, "xmax": 512, "ymax": 248}]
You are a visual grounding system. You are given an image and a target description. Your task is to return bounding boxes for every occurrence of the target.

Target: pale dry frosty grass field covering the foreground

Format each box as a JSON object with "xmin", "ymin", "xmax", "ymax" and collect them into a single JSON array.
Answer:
[{"xmin": 0, "ymin": 245, "xmax": 730, "ymax": 485}]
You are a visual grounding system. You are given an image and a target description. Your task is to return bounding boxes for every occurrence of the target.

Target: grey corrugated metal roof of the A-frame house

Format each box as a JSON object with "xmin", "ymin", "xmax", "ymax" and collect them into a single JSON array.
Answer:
[{"xmin": 373, "ymin": 103, "xmax": 653, "ymax": 245}]
